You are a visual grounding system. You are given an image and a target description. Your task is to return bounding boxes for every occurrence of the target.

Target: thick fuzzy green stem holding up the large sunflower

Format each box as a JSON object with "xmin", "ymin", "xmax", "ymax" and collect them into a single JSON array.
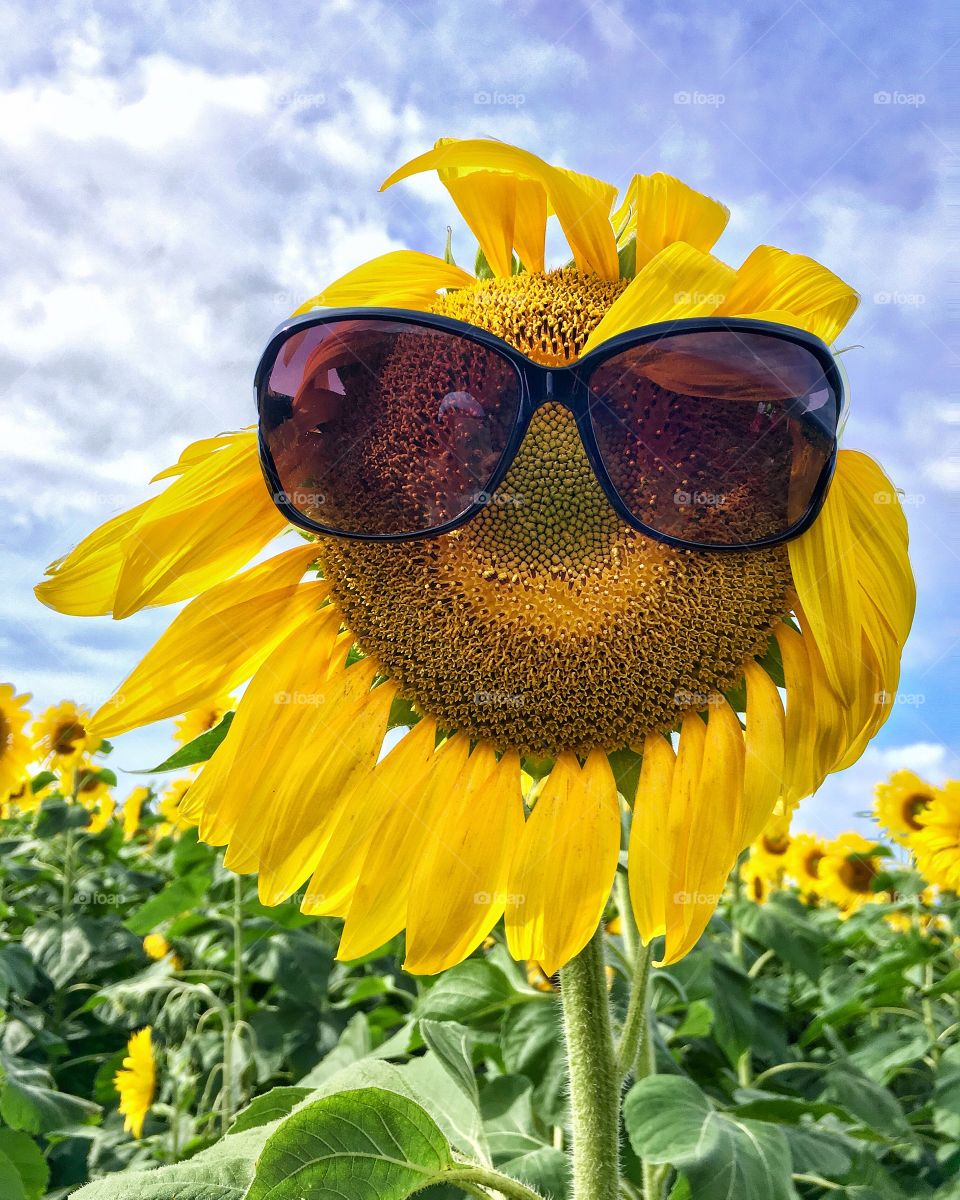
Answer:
[{"xmin": 560, "ymin": 924, "xmax": 620, "ymax": 1200}]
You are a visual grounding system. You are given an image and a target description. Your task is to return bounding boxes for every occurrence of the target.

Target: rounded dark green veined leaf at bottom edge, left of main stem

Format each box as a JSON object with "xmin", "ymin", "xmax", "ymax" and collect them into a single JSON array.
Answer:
[{"xmin": 246, "ymin": 1087, "xmax": 454, "ymax": 1200}]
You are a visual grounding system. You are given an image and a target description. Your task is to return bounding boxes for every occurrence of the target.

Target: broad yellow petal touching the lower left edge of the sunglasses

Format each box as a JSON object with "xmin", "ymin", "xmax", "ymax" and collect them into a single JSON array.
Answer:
[{"xmin": 113, "ymin": 433, "xmax": 286, "ymax": 619}]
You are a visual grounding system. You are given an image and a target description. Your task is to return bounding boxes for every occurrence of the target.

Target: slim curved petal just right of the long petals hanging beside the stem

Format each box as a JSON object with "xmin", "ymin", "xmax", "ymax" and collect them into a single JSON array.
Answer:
[{"xmin": 738, "ymin": 659, "xmax": 786, "ymax": 850}]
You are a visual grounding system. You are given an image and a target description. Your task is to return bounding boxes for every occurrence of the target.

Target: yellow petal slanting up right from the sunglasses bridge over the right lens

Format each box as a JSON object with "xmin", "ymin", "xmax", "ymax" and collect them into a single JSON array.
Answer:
[{"xmin": 581, "ymin": 242, "xmax": 733, "ymax": 356}]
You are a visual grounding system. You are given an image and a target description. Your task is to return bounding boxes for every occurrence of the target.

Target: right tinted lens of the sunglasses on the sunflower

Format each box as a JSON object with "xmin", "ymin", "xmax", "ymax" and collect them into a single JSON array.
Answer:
[{"xmin": 580, "ymin": 330, "xmax": 839, "ymax": 546}]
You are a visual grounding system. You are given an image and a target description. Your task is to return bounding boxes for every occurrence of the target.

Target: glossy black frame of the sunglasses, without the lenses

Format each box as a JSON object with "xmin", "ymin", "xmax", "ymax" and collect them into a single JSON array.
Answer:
[{"xmin": 253, "ymin": 307, "xmax": 845, "ymax": 553}]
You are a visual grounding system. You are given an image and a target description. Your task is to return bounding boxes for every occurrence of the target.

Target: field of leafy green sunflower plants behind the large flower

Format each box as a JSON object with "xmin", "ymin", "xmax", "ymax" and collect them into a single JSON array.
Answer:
[{"xmin": 0, "ymin": 688, "xmax": 960, "ymax": 1200}]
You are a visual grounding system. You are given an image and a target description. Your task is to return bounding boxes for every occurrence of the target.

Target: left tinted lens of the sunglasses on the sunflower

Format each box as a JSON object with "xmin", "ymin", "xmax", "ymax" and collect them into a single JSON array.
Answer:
[{"xmin": 260, "ymin": 318, "xmax": 520, "ymax": 535}]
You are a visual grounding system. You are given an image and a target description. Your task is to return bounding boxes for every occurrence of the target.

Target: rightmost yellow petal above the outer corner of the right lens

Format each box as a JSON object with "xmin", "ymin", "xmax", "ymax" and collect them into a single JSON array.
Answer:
[{"xmin": 716, "ymin": 246, "xmax": 859, "ymax": 344}]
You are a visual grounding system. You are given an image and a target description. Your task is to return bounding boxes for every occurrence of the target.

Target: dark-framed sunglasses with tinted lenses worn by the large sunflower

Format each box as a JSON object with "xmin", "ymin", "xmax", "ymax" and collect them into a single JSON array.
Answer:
[{"xmin": 254, "ymin": 308, "xmax": 844, "ymax": 550}]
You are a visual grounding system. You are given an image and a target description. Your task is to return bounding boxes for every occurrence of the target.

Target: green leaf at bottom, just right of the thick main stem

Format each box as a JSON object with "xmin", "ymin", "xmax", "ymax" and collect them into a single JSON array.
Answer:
[{"xmin": 624, "ymin": 1075, "xmax": 797, "ymax": 1200}]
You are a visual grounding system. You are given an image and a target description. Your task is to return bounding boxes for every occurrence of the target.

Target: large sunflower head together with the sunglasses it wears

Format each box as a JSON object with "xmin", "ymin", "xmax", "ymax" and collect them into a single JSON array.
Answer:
[{"xmin": 37, "ymin": 139, "xmax": 914, "ymax": 976}]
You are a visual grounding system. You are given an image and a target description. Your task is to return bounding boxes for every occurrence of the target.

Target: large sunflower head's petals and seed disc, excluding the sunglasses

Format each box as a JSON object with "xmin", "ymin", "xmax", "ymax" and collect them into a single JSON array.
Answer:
[{"xmin": 37, "ymin": 139, "xmax": 914, "ymax": 974}]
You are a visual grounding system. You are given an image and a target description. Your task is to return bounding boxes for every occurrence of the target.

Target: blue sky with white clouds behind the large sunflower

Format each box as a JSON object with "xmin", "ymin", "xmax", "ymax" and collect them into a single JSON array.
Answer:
[{"xmin": 0, "ymin": 0, "xmax": 960, "ymax": 833}]
